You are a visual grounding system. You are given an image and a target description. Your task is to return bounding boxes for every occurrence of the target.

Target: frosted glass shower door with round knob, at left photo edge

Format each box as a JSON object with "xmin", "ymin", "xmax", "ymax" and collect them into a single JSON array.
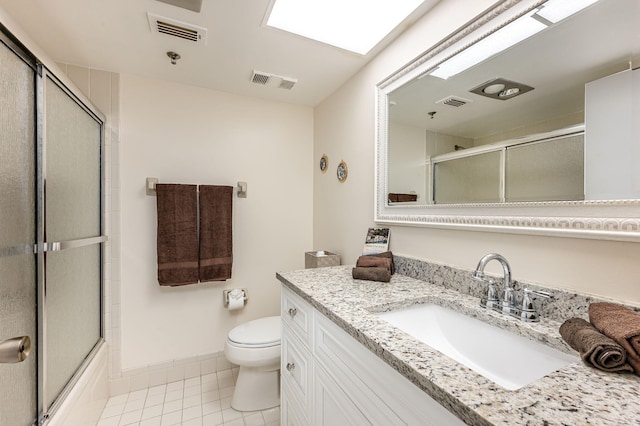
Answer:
[{"xmin": 0, "ymin": 35, "xmax": 38, "ymax": 426}]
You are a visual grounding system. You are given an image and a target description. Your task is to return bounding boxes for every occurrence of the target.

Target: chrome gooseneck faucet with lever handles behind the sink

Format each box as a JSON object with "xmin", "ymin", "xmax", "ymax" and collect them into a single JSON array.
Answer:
[{"xmin": 473, "ymin": 253, "xmax": 551, "ymax": 322}]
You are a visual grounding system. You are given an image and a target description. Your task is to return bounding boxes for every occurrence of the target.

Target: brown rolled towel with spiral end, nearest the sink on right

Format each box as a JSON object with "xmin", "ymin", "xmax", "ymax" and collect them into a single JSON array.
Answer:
[{"xmin": 560, "ymin": 318, "xmax": 633, "ymax": 372}]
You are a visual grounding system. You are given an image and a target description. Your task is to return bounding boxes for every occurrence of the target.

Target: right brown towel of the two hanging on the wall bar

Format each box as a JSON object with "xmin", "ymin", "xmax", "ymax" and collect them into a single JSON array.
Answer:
[{"xmin": 200, "ymin": 185, "xmax": 233, "ymax": 281}]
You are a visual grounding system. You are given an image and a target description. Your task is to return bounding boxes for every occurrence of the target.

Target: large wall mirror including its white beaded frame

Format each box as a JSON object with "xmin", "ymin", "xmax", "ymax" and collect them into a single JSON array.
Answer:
[{"xmin": 375, "ymin": 0, "xmax": 640, "ymax": 241}]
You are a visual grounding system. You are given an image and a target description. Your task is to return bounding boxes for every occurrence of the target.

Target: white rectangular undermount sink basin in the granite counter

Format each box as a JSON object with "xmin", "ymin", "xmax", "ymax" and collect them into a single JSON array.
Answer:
[{"xmin": 376, "ymin": 304, "xmax": 579, "ymax": 390}]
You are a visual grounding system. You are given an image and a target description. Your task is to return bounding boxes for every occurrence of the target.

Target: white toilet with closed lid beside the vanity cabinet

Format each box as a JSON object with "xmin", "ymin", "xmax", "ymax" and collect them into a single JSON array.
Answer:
[{"xmin": 224, "ymin": 316, "xmax": 281, "ymax": 411}]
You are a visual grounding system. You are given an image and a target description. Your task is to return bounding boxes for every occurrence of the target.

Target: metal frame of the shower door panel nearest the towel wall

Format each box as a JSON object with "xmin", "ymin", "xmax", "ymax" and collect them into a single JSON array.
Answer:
[{"xmin": 35, "ymin": 62, "xmax": 108, "ymax": 425}]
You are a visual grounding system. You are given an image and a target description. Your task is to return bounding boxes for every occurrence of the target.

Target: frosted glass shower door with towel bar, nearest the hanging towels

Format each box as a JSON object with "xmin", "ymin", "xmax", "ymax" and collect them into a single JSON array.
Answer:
[{"xmin": 40, "ymin": 73, "xmax": 105, "ymax": 410}]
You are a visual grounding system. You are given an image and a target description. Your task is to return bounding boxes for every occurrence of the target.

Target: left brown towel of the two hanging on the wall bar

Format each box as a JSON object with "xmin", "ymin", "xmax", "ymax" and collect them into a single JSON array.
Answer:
[{"xmin": 156, "ymin": 184, "xmax": 198, "ymax": 286}]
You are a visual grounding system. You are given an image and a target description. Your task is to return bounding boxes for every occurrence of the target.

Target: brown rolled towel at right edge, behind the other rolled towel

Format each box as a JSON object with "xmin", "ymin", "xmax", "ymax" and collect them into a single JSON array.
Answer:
[{"xmin": 589, "ymin": 302, "xmax": 640, "ymax": 375}]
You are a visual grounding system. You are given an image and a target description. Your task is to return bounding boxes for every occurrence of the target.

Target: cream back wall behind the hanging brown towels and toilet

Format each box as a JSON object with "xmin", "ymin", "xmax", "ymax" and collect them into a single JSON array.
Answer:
[{"xmin": 121, "ymin": 75, "xmax": 313, "ymax": 371}]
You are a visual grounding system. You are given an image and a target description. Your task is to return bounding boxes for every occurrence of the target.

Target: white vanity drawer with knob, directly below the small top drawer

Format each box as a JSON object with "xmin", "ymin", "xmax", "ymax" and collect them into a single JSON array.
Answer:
[{"xmin": 281, "ymin": 325, "xmax": 313, "ymax": 411}]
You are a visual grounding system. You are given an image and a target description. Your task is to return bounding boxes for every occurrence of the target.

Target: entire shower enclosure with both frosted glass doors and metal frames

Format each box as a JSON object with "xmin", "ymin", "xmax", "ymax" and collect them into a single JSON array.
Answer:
[{"xmin": 0, "ymin": 26, "xmax": 106, "ymax": 426}]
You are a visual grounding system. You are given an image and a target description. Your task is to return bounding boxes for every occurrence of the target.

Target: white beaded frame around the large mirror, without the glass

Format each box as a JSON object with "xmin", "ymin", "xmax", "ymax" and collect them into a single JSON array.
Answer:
[{"xmin": 374, "ymin": 0, "xmax": 640, "ymax": 241}]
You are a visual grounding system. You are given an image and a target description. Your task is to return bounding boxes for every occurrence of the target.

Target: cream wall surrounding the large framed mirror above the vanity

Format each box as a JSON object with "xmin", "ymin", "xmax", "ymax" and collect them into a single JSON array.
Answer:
[{"xmin": 314, "ymin": 0, "xmax": 640, "ymax": 304}]
